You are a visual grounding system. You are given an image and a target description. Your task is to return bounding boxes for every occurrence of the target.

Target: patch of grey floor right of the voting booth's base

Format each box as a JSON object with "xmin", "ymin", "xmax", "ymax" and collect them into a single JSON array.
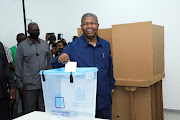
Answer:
[{"xmin": 164, "ymin": 109, "xmax": 180, "ymax": 120}]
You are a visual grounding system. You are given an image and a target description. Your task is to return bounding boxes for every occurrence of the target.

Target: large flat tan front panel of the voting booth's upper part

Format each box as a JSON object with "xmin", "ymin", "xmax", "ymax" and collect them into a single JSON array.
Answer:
[{"xmin": 112, "ymin": 22, "xmax": 153, "ymax": 80}]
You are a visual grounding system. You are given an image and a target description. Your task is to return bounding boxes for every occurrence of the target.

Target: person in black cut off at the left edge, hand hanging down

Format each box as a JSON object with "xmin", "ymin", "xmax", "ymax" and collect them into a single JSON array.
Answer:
[{"xmin": 0, "ymin": 42, "xmax": 16, "ymax": 120}]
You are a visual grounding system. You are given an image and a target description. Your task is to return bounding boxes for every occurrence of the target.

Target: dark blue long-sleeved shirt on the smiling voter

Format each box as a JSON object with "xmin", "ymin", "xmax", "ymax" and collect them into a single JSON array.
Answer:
[{"xmin": 51, "ymin": 34, "xmax": 115, "ymax": 109}]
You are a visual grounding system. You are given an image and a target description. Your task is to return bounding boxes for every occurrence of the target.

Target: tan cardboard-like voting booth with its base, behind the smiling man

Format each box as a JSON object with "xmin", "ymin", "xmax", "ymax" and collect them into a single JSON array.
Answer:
[{"xmin": 78, "ymin": 22, "xmax": 165, "ymax": 120}]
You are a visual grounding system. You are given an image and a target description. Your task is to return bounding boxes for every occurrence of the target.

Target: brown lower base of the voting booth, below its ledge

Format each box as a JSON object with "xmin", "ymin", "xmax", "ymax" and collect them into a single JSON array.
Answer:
[{"xmin": 112, "ymin": 80, "xmax": 164, "ymax": 120}]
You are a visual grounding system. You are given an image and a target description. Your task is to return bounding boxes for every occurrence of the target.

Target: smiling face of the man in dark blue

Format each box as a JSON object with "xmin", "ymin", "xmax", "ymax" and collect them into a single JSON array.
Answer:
[{"xmin": 81, "ymin": 17, "xmax": 99, "ymax": 39}]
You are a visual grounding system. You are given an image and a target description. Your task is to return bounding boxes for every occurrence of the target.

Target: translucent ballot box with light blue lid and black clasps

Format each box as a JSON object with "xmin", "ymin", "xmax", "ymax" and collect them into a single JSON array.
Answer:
[{"xmin": 40, "ymin": 67, "xmax": 98, "ymax": 119}]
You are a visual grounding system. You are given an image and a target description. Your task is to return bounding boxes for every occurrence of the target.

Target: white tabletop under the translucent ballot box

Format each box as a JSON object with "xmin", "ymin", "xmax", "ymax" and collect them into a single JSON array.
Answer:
[{"xmin": 13, "ymin": 111, "xmax": 105, "ymax": 120}]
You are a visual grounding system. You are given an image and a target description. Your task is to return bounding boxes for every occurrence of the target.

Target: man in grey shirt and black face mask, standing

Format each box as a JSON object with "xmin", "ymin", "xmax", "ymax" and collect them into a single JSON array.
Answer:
[{"xmin": 15, "ymin": 22, "xmax": 52, "ymax": 114}]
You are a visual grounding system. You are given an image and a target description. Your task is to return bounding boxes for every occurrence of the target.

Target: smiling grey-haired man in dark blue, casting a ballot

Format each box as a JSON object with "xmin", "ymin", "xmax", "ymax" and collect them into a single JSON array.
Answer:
[{"xmin": 51, "ymin": 13, "xmax": 115, "ymax": 119}]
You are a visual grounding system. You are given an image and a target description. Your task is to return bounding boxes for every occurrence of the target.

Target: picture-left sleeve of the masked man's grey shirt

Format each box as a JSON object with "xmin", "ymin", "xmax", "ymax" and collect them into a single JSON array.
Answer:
[{"xmin": 15, "ymin": 46, "xmax": 23, "ymax": 87}]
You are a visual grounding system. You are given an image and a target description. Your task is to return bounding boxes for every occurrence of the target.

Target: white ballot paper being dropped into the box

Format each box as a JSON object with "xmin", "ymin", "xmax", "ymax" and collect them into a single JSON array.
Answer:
[{"xmin": 65, "ymin": 62, "xmax": 77, "ymax": 72}]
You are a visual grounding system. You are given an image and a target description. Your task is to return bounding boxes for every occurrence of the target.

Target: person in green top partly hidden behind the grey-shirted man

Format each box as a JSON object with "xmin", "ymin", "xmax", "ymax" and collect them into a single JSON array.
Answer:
[{"xmin": 10, "ymin": 33, "xmax": 26, "ymax": 119}]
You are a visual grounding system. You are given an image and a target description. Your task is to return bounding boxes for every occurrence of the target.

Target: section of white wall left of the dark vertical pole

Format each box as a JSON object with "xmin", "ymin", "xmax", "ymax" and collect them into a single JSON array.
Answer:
[{"xmin": 0, "ymin": 0, "xmax": 24, "ymax": 47}]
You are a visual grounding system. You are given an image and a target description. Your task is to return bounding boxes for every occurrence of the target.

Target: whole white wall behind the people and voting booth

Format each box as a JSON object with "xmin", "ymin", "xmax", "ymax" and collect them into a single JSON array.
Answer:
[{"xmin": 0, "ymin": 0, "xmax": 180, "ymax": 110}]
